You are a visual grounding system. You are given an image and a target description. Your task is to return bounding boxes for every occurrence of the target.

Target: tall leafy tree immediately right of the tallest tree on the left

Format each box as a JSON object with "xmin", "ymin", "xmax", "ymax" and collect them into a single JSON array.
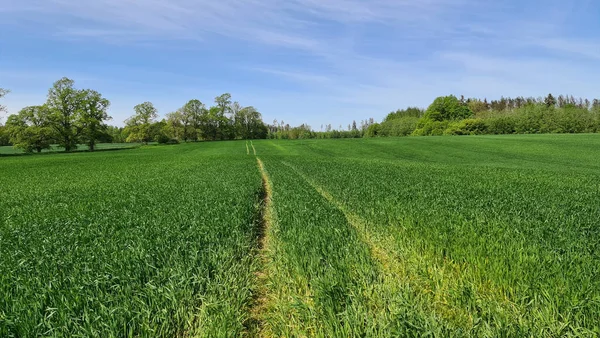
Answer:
[{"xmin": 77, "ymin": 89, "xmax": 111, "ymax": 151}]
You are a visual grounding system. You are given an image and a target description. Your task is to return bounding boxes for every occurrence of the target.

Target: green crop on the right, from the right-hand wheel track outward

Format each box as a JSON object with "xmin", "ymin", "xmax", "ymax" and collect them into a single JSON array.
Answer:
[{"xmin": 255, "ymin": 135, "xmax": 600, "ymax": 337}]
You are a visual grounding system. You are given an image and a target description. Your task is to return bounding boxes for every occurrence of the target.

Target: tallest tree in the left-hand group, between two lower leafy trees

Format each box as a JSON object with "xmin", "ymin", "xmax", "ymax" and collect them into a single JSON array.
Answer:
[{"xmin": 46, "ymin": 77, "xmax": 83, "ymax": 152}]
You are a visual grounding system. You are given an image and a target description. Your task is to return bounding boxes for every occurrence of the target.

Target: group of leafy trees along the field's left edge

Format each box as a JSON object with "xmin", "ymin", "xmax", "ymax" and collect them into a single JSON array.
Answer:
[{"xmin": 0, "ymin": 78, "xmax": 269, "ymax": 152}]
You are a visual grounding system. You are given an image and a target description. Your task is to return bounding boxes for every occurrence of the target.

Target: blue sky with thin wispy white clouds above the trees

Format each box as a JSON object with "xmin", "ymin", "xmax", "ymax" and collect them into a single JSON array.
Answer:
[{"xmin": 0, "ymin": 0, "xmax": 600, "ymax": 130}]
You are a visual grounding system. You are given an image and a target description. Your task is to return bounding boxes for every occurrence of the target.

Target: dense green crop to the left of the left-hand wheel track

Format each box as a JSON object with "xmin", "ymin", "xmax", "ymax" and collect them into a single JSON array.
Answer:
[{"xmin": 0, "ymin": 143, "xmax": 261, "ymax": 337}]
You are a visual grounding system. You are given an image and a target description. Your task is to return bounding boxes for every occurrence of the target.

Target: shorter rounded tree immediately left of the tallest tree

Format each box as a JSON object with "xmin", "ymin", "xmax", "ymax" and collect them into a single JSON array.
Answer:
[{"xmin": 6, "ymin": 106, "xmax": 53, "ymax": 153}]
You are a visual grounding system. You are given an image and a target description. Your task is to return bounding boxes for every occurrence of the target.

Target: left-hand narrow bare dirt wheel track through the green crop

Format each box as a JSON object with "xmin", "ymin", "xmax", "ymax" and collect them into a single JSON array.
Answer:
[{"xmin": 246, "ymin": 157, "xmax": 274, "ymax": 337}]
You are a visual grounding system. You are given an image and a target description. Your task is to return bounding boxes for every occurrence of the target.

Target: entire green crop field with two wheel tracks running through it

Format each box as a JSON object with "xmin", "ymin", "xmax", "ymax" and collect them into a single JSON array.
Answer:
[{"xmin": 0, "ymin": 135, "xmax": 600, "ymax": 337}]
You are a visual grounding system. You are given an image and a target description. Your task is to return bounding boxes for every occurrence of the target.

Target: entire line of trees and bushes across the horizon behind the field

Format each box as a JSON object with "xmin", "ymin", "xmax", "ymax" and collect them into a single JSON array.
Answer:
[{"xmin": 0, "ymin": 78, "xmax": 600, "ymax": 152}]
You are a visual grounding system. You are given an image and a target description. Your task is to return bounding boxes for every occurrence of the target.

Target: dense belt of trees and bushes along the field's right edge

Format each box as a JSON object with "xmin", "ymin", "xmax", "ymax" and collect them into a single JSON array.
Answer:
[{"xmin": 365, "ymin": 94, "xmax": 600, "ymax": 137}]
